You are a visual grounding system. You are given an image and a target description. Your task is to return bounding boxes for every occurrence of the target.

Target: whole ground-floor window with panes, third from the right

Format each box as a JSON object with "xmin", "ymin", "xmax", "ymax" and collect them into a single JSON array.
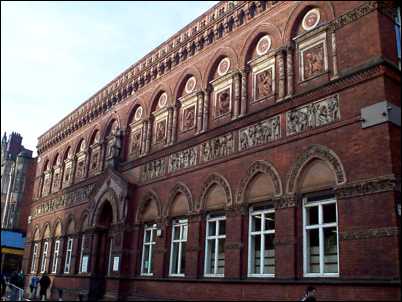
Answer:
[{"xmin": 204, "ymin": 215, "xmax": 226, "ymax": 277}]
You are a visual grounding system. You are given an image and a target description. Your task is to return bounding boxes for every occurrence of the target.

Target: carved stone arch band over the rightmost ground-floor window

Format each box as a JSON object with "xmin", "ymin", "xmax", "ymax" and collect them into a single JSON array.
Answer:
[{"xmin": 286, "ymin": 145, "xmax": 346, "ymax": 194}]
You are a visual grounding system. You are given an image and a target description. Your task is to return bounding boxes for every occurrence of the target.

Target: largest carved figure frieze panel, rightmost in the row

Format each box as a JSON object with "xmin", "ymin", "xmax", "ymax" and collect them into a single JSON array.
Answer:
[{"xmin": 286, "ymin": 94, "xmax": 340, "ymax": 135}]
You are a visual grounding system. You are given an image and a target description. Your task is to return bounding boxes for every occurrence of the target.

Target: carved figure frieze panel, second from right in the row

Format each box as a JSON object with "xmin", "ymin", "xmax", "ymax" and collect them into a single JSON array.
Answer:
[{"xmin": 239, "ymin": 115, "xmax": 281, "ymax": 151}]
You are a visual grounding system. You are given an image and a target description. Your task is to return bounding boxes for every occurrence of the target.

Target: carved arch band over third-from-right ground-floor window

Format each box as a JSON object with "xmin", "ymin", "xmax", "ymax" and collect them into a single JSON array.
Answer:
[{"xmin": 198, "ymin": 173, "xmax": 233, "ymax": 211}]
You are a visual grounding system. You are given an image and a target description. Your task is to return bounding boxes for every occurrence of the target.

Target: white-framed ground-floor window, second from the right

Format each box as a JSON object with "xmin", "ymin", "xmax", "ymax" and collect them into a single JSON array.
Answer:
[{"xmin": 248, "ymin": 208, "xmax": 275, "ymax": 277}]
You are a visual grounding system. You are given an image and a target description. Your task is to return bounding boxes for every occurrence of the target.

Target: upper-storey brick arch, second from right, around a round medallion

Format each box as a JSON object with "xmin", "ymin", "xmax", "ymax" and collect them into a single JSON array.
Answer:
[{"xmin": 240, "ymin": 21, "xmax": 283, "ymax": 67}]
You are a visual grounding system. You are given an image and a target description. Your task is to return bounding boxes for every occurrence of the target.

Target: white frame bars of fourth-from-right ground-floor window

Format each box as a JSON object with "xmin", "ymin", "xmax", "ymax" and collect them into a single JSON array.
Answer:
[{"xmin": 169, "ymin": 219, "xmax": 188, "ymax": 277}]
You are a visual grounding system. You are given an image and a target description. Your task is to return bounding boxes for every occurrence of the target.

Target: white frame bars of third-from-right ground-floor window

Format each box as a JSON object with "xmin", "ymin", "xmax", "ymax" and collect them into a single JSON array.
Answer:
[{"xmin": 204, "ymin": 215, "xmax": 226, "ymax": 277}]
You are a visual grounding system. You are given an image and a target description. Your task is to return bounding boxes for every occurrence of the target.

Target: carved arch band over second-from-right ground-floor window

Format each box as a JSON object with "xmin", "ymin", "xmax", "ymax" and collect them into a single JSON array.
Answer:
[{"xmin": 236, "ymin": 160, "xmax": 283, "ymax": 204}]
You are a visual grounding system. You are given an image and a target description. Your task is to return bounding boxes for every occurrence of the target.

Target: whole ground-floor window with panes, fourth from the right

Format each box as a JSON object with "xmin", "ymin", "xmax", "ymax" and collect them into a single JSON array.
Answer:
[{"xmin": 169, "ymin": 220, "xmax": 188, "ymax": 276}]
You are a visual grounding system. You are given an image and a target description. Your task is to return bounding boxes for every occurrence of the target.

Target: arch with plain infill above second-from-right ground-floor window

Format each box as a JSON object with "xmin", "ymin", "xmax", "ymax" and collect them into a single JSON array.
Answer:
[{"xmin": 236, "ymin": 160, "xmax": 283, "ymax": 204}]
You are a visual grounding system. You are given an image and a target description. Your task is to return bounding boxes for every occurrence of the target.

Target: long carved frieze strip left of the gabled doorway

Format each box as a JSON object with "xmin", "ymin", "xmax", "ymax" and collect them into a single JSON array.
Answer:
[{"xmin": 32, "ymin": 184, "xmax": 95, "ymax": 218}]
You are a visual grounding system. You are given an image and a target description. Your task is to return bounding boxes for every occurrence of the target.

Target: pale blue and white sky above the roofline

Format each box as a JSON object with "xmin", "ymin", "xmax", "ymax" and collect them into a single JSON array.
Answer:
[{"xmin": 1, "ymin": 1, "xmax": 218, "ymax": 155}]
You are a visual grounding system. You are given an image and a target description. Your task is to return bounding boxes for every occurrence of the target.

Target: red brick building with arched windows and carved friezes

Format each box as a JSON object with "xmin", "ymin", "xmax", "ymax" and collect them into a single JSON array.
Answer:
[{"xmin": 25, "ymin": 1, "xmax": 401, "ymax": 301}]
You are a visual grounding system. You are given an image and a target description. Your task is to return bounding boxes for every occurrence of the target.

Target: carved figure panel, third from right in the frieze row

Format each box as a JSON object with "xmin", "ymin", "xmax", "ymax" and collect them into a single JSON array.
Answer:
[{"xmin": 201, "ymin": 133, "xmax": 235, "ymax": 162}]
